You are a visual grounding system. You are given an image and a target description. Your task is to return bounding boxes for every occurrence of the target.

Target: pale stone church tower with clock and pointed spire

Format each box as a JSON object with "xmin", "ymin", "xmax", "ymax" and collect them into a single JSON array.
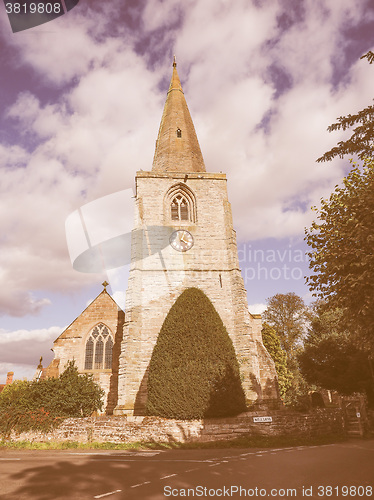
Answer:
[{"xmin": 114, "ymin": 61, "xmax": 278, "ymax": 415}]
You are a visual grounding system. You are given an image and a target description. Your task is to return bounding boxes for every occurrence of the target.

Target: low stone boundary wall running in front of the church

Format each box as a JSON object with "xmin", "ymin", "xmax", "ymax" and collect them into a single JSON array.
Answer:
[{"xmin": 12, "ymin": 409, "xmax": 344, "ymax": 443}]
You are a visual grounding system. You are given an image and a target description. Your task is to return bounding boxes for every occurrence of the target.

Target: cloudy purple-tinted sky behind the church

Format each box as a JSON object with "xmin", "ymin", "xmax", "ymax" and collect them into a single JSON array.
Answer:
[{"xmin": 0, "ymin": 0, "xmax": 374, "ymax": 383}]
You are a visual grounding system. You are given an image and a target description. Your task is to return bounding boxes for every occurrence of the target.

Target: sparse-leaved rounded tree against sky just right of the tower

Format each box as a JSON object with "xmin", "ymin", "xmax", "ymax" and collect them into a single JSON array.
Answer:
[{"xmin": 263, "ymin": 292, "xmax": 309, "ymax": 359}]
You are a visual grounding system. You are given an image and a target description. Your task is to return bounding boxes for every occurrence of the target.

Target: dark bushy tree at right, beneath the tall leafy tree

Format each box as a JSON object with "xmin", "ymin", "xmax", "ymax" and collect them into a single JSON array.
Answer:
[{"xmin": 299, "ymin": 303, "xmax": 374, "ymax": 406}]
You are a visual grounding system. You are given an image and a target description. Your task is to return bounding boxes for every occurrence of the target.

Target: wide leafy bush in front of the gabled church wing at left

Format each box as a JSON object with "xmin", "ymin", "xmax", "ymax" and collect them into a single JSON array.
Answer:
[{"xmin": 0, "ymin": 361, "xmax": 104, "ymax": 439}]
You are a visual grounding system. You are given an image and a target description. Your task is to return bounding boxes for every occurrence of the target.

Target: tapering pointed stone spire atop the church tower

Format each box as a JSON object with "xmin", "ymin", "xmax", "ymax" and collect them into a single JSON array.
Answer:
[{"xmin": 152, "ymin": 56, "xmax": 206, "ymax": 173}]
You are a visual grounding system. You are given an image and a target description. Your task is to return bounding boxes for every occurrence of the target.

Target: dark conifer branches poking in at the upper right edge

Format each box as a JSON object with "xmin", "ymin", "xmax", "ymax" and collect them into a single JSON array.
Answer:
[{"xmin": 317, "ymin": 52, "xmax": 374, "ymax": 162}]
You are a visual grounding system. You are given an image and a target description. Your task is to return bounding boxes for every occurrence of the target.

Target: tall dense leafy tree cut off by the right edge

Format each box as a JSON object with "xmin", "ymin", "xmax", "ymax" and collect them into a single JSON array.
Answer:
[{"xmin": 305, "ymin": 162, "xmax": 374, "ymax": 352}]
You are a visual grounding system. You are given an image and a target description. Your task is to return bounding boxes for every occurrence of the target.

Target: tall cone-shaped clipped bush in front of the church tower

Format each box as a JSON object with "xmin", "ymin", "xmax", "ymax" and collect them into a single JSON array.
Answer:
[{"xmin": 146, "ymin": 288, "xmax": 246, "ymax": 419}]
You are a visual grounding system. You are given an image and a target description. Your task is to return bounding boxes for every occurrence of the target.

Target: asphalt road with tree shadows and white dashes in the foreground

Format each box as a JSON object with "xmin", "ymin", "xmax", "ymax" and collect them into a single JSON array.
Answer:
[{"xmin": 0, "ymin": 440, "xmax": 374, "ymax": 500}]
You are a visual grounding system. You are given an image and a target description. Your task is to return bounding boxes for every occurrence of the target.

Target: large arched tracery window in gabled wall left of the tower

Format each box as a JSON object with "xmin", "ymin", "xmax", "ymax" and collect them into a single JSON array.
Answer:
[{"xmin": 84, "ymin": 323, "xmax": 113, "ymax": 370}]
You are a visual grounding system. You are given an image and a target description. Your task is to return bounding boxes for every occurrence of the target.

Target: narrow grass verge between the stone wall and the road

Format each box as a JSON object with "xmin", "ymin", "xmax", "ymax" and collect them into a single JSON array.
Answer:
[{"xmin": 0, "ymin": 435, "xmax": 346, "ymax": 451}]
